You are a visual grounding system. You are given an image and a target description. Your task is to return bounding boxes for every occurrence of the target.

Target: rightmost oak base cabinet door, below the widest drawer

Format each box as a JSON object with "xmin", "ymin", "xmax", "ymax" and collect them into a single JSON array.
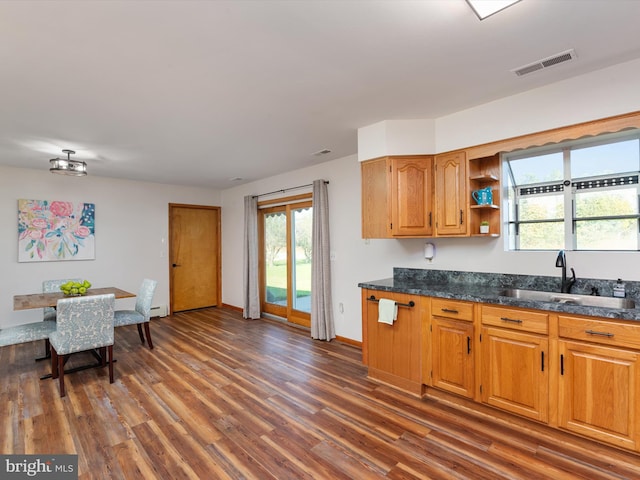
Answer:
[{"xmin": 558, "ymin": 341, "xmax": 640, "ymax": 450}]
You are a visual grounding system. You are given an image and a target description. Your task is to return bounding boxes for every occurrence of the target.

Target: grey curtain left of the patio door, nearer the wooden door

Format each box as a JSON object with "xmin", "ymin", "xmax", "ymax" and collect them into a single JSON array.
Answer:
[{"xmin": 242, "ymin": 195, "xmax": 260, "ymax": 318}]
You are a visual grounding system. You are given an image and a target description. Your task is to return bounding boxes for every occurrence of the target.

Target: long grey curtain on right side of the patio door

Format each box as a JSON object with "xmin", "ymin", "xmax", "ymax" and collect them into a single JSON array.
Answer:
[{"xmin": 311, "ymin": 180, "xmax": 336, "ymax": 340}]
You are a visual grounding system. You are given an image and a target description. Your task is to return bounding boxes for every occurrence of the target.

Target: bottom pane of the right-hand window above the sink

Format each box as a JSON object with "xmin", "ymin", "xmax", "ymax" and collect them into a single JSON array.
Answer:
[{"xmin": 576, "ymin": 219, "xmax": 638, "ymax": 250}]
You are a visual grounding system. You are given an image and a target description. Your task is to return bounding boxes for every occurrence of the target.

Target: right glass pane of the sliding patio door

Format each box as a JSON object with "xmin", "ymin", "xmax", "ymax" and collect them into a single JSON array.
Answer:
[{"xmin": 291, "ymin": 208, "xmax": 313, "ymax": 313}]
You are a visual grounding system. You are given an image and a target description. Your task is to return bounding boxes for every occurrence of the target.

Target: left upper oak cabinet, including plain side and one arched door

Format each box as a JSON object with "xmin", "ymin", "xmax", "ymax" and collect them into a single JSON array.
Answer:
[{"xmin": 361, "ymin": 155, "xmax": 433, "ymax": 238}]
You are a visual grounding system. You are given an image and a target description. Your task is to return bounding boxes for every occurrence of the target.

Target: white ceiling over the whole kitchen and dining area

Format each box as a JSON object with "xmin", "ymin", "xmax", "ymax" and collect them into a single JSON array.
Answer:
[{"xmin": 0, "ymin": 0, "xmax": 640, "ymax": 188}]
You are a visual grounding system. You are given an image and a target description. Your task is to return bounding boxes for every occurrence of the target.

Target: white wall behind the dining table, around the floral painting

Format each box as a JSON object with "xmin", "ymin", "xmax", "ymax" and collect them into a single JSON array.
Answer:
[{"xmin": 0, "ymin": 167, "xmax": 220, "ymax": 328}]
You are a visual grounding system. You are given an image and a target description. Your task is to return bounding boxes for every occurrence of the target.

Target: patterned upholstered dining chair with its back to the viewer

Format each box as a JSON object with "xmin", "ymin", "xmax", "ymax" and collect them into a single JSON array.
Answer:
[{"xmin": 49, "ymin": 293, "xmax": 116, "ymax": 397}]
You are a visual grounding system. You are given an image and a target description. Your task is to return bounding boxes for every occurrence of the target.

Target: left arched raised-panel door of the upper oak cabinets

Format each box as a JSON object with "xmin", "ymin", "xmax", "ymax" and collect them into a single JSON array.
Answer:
[{"xmin": 391, "ymin": 157, "xmax": 433, "ymax": 237}]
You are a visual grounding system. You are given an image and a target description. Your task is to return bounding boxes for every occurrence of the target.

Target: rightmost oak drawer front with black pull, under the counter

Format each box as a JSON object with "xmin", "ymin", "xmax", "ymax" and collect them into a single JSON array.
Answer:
[{"xmin": 558, "ymin": 315, "xmax": 640, "ymax": 349}]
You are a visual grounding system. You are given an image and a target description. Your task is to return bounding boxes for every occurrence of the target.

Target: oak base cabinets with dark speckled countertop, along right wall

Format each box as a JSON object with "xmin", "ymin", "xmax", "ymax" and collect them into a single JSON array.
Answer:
[{"xmin": 358, "ymin": 268, "xmax": 640, "ymax": 452}]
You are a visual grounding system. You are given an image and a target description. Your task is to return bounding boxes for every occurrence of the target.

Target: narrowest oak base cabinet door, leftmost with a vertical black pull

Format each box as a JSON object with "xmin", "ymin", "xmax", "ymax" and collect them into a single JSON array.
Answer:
[{"xmin": 431, "ymin": 317, "xmax": 475, "ymax": 398}]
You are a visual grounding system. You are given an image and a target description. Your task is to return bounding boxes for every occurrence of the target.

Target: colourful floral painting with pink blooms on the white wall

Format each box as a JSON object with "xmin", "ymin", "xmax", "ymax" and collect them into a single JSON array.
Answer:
[{"xmin": 18, "ymin": 200, "xmax": 96, "ymax": 262}]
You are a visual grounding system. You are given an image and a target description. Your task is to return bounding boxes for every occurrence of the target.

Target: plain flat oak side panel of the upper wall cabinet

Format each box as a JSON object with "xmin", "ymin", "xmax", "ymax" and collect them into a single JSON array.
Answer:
[{"xmin": 360, "ymin": 158, "xmax": 391, "ymax": 238}]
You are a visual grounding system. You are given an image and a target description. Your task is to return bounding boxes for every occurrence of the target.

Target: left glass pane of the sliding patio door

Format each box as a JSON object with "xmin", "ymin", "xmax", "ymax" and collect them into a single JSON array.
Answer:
[{"xmin": 264, "ymin": 213, "xmax": 287, "ymax": 306}]
